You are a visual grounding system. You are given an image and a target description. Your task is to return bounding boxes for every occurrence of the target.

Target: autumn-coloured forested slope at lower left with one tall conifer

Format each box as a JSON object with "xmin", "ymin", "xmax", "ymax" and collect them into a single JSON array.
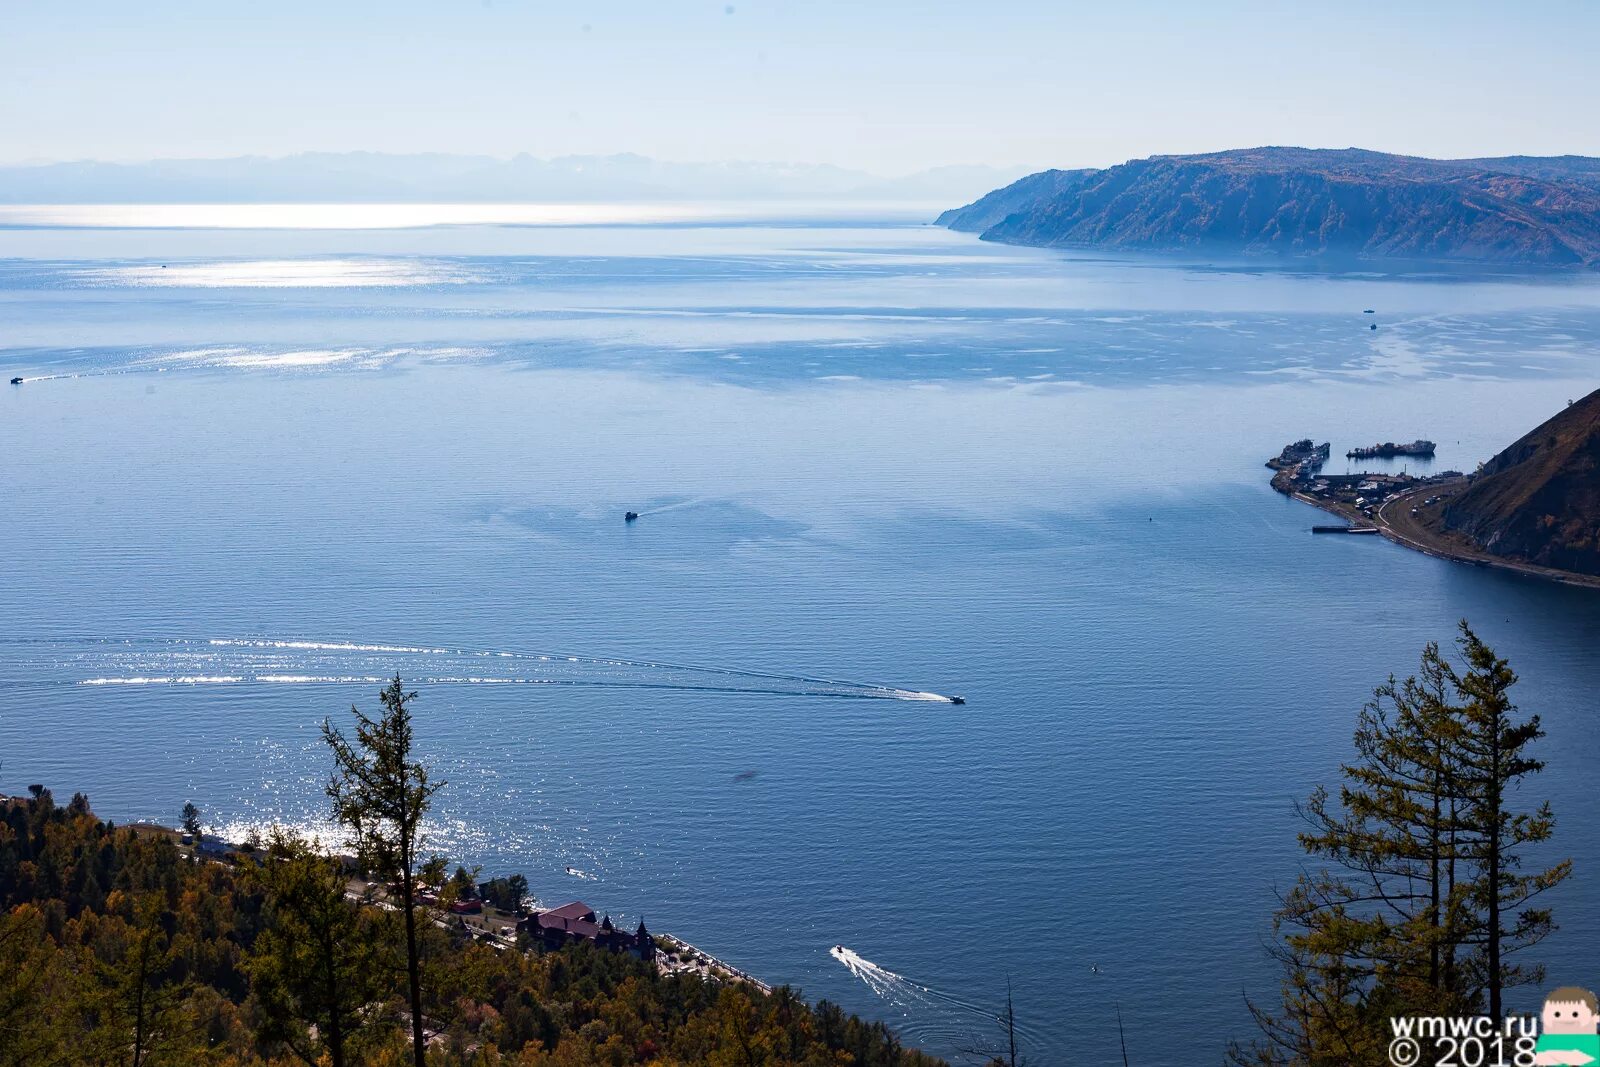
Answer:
[{"xmin": 0, "ymin": 678, "xmax": 941, "ymax": 1067}]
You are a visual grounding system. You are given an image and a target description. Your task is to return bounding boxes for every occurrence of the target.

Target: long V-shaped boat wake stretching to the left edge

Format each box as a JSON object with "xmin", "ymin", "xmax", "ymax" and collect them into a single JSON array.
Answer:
[{"xmin": 0, "ymin": 637, "xmax": 962, "ymax": 704}]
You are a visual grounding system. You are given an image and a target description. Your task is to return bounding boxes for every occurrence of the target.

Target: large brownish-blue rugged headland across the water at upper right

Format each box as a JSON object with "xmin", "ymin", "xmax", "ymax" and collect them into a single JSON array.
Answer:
[{"xmin": 939, "ymin": 147, "xmax": 1600, "ymax": 267}]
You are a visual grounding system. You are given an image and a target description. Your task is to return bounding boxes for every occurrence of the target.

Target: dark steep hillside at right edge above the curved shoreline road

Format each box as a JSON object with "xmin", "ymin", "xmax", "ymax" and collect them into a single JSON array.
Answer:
[{"xmin": 1442, "ymin": 390, "xmax": 1600, "ymax": 574}]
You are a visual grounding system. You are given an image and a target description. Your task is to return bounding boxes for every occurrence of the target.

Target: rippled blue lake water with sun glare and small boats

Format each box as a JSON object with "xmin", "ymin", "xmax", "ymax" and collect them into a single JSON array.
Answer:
[{"xmin": 0, "ymin": 208, "xmax": 1600, "ymax": 1062}]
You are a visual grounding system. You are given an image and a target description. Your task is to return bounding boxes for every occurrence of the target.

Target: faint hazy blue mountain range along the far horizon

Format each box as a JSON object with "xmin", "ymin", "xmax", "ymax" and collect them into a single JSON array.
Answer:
[{"xmin": 0, "ymin": 152, "xmax": 1026, "ymax": 203}]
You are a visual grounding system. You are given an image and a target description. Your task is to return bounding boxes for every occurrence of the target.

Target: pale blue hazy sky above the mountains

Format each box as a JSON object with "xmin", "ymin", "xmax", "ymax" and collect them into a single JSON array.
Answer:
[{"xmin": 0, "ymin": 0, "xmax": 1600, "ymax": 174}]
